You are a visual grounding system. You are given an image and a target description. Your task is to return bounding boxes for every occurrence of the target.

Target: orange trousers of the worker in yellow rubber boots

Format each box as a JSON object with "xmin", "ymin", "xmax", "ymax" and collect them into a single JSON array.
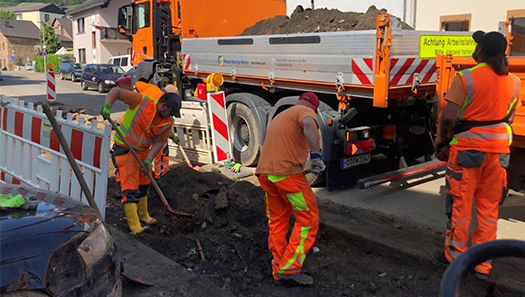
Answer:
[{"xmin": 111, "ymin": 145, "xmax": 151, "ymax": 204}]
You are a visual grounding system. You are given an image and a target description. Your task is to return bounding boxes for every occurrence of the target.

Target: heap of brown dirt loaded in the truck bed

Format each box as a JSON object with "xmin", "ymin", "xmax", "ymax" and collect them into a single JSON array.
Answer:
[{"xmin": 241, "ymin": 5, "xmax": 412, "ymax": 35}]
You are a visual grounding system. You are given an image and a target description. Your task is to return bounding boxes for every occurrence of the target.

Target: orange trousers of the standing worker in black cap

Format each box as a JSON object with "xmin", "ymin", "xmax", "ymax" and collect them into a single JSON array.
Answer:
[{"xmin": 445, "ymin": 146, "xmax": 508, "ymax": 274}]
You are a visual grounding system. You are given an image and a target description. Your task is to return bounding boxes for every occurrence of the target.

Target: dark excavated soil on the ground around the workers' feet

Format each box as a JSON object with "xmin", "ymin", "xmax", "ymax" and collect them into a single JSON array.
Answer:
[{"xmin": 106, "ymin": 165, "xmax": 519, "ymax": 296}]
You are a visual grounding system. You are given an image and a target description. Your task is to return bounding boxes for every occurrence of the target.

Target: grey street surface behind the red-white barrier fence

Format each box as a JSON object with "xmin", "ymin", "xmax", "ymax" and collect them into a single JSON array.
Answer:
[{"xmin": 0, "ymin": 70, "xmax": 126, "ymax": 115}]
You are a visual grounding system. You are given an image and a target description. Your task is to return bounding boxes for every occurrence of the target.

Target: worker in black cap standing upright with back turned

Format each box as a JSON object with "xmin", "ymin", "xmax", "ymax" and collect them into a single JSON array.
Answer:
[{"xmin": 434, "ymin": 31, "xmax": 520, "ymax": 279}]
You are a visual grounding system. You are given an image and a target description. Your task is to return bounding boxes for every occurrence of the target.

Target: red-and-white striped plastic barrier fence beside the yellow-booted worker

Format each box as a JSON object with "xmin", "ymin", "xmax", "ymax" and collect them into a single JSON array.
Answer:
[{"xmin": 0, "ymin": 97, "xmax": 111, "ymax": 215}]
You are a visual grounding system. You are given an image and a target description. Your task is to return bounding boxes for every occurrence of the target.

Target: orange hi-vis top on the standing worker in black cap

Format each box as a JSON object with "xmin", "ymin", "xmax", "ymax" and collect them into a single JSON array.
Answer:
[{"xmin": 450, "ymin": 63, "xmax": 520, "ymax": 154}]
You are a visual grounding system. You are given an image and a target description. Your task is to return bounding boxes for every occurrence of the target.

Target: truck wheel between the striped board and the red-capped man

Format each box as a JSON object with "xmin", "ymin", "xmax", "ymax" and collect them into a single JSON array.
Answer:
[{"xmin": 228, "ymin": 103, "xmax": 260, "ymax": 166}]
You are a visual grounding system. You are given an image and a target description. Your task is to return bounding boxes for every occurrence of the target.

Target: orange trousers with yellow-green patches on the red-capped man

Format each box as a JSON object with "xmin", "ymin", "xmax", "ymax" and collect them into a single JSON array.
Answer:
[{"xmin": 258, "ymin": 173, "xmax": 319, "ymax": 279}]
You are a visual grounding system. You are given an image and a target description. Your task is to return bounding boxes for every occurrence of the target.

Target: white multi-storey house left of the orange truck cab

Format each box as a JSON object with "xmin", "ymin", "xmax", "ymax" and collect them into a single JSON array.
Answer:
[{"xmin": 67, "ymin": 0, "xmax": 131, "ymax": 64}]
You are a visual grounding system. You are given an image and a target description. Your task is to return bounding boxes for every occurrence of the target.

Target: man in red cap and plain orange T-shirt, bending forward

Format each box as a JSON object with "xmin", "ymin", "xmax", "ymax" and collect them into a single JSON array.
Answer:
[{"xmin": 255, "ymin": 92, "xmax": 325, "ymax": 286}]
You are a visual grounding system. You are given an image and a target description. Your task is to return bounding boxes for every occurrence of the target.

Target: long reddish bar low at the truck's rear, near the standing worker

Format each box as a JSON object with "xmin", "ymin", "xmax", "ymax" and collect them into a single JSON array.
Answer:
[{"xmin": 357, "ymin": 160, "xmax": 447, "ymax": 190}]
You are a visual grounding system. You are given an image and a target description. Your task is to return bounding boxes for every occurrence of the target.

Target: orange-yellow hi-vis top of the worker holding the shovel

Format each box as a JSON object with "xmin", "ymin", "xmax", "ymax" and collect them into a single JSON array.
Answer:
[{"xmin": 113, "ymin": 96, "xmax": 172, "ymax": 151}]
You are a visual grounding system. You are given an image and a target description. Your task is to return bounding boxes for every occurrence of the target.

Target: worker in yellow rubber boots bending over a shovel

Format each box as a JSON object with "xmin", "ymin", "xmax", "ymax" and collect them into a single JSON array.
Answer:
[{"xmin": 101, "ymin": 84, "xmax": 181, "ymax": 234}]
